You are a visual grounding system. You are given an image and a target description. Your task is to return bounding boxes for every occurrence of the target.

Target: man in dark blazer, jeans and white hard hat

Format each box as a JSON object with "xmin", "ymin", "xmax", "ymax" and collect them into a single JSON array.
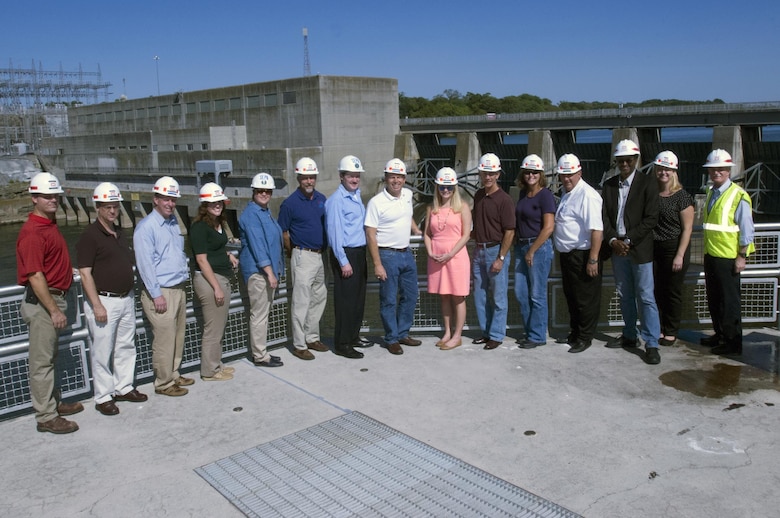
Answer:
[{"xmin": 601, "ymin": 140, "xmax": 661, "ymax": 365}]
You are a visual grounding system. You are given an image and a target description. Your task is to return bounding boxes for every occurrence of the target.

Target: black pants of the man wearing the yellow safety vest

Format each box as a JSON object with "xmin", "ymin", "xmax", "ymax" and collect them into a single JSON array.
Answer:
[{"xmin": 704, "ymin": 254, "xmax": 742, "ymax": 347}]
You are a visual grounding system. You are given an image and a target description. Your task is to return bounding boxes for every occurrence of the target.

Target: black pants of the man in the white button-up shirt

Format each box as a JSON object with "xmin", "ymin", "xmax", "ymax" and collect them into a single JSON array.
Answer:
[{"xmin": 558, "ymin": 250, "xmax": 602, "ymax": 341}]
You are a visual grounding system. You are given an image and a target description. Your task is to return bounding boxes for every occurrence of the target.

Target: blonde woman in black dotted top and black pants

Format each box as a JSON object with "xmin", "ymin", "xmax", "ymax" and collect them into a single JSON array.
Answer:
[{"xmin": 653, "ymin": 151, "xmax": 693, "ymax": 346}]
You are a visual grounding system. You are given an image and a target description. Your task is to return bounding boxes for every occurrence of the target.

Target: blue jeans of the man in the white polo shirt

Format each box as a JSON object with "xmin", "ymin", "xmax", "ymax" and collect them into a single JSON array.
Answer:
[{"xmin": 379, "ymin": 249, "xmax": 418, "ymax": 344}]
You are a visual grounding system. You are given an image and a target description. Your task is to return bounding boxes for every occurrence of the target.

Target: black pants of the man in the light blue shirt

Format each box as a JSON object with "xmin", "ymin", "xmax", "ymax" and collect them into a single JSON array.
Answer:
[{"xmin": 330, "ymin": 246, "xmax": 368, "ymax": 349}]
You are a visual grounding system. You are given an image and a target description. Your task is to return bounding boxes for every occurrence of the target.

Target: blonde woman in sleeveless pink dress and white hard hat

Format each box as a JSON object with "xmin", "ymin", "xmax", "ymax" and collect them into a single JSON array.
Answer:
[{"xmin": 424, "ymin": 167, "xmax": 471, "ymax": 351}]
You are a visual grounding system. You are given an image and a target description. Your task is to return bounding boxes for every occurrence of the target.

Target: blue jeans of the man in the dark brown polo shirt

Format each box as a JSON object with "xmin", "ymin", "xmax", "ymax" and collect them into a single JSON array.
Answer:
[{"xmin": 471, "ymin": 245, "xmax": 512, "ymax": 342}]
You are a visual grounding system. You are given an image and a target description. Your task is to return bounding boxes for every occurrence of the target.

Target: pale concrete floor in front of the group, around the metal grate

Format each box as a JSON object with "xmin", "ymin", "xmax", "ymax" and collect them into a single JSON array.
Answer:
[{"xmin": 0, "ymin": 330, "xmax": 780, "ymax": 518}]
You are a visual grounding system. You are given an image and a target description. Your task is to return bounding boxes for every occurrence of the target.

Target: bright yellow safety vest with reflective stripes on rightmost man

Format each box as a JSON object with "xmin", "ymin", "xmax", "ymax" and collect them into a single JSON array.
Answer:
[{"xmin": 704, "ymin": 182, "xmax": 756, "ymax": 259}]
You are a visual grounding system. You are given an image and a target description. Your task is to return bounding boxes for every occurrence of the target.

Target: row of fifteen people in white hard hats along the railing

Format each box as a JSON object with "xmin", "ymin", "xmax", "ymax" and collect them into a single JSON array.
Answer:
[{"xmin": 17, "ymin": 140, "xmax": 755, "ymax": 434}]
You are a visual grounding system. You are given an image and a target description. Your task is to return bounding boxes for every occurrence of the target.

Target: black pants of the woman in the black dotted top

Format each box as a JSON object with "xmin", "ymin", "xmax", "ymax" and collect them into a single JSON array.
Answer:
[{"xmin": 653, "ymin": 239, "xmax": 691, "ymax": 337}]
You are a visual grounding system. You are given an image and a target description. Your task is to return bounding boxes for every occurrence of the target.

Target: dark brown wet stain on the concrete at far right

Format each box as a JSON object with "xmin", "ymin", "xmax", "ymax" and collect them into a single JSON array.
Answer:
[{"xmin": 658, "ymin": 363, "xmax": 780, "ymax": 399}]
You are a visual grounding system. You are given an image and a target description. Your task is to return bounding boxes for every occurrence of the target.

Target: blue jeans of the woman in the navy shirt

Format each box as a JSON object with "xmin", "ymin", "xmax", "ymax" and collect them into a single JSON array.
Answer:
[{"xmin": 515, "ymin": 239, "xmax": 553, "ymax": 343}]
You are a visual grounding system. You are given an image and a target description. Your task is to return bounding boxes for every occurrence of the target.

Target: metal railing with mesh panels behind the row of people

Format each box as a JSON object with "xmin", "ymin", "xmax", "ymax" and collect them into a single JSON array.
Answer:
[{"xmin": 0, "ymin": 223, "xmax": 780, "ymax": 419}]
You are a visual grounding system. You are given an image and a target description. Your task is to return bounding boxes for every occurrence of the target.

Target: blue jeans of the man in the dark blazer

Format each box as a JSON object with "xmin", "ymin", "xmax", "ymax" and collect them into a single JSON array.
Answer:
[{"xmin": 612, "ymin": 255, "xmax": 661, "ymax": 347}]
